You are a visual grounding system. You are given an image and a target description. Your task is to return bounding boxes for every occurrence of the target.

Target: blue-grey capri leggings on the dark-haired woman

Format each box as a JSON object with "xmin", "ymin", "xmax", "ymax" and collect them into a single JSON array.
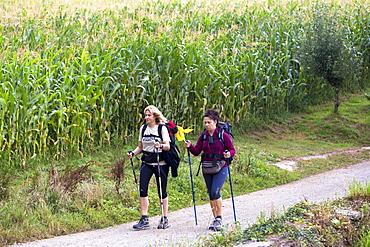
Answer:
[{"xmin": 203, "ymin": 166, "xmax": 229, "ymax": 201}]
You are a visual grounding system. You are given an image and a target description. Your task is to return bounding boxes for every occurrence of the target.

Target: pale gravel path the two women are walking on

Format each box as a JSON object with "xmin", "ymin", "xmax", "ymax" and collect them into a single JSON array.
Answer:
[{"xmin": 12, "ymin": 160, "xmax": 370, "ymax": 247}]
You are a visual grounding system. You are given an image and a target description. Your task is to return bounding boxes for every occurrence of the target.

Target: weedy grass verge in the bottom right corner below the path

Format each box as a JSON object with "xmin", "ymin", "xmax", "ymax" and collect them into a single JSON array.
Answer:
[{"xmin": 200, "ymin": 182, "xmax": 370, "ymax": 247}]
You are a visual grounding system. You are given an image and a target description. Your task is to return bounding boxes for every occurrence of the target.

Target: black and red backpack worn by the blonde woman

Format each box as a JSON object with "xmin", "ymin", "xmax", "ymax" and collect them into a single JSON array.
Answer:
[{"xmin": 142, "ymin": 121, "xmax": 181, "ymax": 177}]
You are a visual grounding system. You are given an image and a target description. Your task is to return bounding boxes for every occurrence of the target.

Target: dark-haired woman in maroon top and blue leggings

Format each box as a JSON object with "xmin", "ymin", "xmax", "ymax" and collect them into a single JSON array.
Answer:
[{"xmin": 185, "ymin": 109, "xmax": 235, "ymax": 231}]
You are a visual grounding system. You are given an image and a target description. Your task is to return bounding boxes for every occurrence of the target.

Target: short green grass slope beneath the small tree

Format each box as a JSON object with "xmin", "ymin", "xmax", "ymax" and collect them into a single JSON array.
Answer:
[{"xmin": 243, "ymin": 92, "xmax": 370, "ymax": 158}]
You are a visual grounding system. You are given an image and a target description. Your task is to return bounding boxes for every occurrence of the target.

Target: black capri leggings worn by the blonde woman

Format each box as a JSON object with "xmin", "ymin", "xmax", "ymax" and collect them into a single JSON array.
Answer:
[{"xmin": 140, "ymin": 163, "xmax": 170, "ymax": 199}]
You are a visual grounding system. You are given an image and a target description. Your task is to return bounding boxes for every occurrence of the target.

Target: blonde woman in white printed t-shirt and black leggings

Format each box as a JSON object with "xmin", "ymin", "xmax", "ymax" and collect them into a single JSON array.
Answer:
[{"xmin": 127, "ymin": 105, "xmax": 170, "ymax": 230}]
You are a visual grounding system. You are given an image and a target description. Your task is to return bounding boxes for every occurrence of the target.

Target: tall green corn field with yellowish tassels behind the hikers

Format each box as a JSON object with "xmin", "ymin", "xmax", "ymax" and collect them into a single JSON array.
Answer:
[{"xmin": 0, "ymin": 0, "xmax": 370, "ymax": 166}]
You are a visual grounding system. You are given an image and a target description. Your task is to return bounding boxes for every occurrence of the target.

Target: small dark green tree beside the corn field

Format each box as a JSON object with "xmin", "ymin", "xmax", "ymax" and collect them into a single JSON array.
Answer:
[{"xmin": 300, "ymin": 4, "xmax": 361, "ymax": 113}]
